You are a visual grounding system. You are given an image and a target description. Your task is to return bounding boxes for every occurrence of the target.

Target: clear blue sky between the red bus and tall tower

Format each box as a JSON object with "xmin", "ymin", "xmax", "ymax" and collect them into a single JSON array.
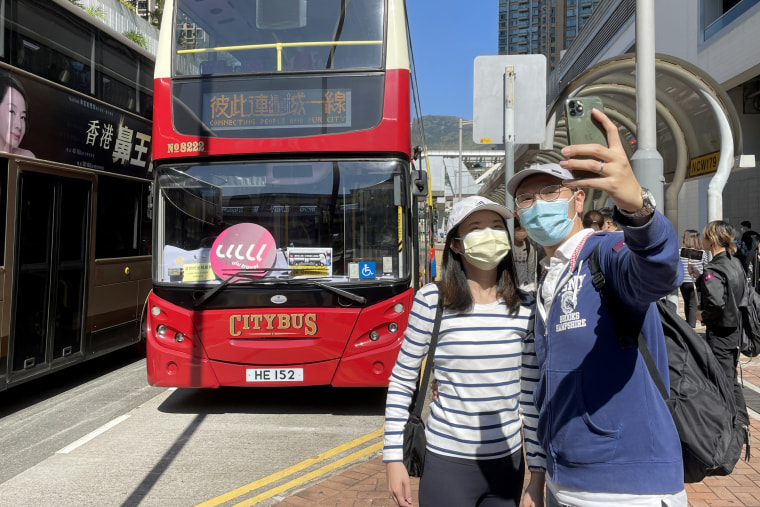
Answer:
[{"xmin": 406, "ymin": 0, "xmax": 499, "ymax": 120}]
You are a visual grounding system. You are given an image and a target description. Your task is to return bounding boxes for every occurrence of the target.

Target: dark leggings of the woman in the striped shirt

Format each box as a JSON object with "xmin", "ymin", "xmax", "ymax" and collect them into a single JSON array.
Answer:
[{"xmin": 420, "ymin": 449, "xmax": 525, "ymax": 507}]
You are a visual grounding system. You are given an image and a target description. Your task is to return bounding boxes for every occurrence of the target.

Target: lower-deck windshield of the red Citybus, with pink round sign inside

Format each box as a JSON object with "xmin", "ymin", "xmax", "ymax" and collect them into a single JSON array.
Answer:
[{"xmin": 154, "ymin": 160, "xmax": 410, "ymax": 285}]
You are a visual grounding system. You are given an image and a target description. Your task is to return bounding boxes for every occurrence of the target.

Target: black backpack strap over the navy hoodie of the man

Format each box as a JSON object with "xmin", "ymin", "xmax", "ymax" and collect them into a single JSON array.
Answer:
[{"xmin": 587, "ymin": 245, "xmax": 670, "ymax": 400}]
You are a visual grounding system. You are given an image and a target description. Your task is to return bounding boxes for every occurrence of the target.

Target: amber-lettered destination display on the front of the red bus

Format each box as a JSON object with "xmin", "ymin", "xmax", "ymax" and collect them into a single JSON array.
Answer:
[{"xmin": 203, "ymin": 88, "xmax": 351, "ymax": 131}]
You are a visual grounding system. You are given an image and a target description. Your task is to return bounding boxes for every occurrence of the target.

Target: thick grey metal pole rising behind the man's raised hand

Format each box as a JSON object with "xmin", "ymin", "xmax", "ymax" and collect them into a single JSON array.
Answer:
[{"xmin": 631, "ymin": 0, "xmax": 664, "ymax": 208}]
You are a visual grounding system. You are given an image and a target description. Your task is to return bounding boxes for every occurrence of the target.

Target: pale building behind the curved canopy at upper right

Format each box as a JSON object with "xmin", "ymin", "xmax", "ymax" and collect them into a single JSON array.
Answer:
[{"xmin": 547, "ymin": 0, "xmax": 760, "ymax": 240}]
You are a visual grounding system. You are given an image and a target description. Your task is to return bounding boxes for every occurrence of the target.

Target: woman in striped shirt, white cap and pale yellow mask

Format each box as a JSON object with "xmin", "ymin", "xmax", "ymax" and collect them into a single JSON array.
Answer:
[{"xmin": 383, "ymin": 196, "xmax": 545, "ymax": 507}]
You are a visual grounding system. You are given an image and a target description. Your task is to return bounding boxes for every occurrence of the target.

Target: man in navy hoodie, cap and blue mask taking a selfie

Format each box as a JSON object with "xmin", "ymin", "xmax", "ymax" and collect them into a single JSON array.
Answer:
[{"xmin": 507, "ymin": 109, "xmax": 687, "ymax": 507}]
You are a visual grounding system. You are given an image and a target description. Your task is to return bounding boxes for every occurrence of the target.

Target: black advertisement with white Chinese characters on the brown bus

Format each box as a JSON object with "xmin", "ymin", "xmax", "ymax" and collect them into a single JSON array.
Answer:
[{"xmin": 5, "ymin": 69, "xmax": 151, "ymax": 178}]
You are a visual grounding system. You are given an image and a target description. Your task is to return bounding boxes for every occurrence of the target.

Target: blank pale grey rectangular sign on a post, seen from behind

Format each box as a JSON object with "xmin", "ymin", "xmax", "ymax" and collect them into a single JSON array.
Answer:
[{"xmin": 472, "ymin": 55, "xmax": 546, "ymax": 144}]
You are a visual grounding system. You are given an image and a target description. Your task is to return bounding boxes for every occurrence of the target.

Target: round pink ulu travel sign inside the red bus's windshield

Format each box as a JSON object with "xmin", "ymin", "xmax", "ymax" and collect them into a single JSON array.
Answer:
[{"xmin": 210, "ymin": 224, "xmax": 277, "ymax": 278}]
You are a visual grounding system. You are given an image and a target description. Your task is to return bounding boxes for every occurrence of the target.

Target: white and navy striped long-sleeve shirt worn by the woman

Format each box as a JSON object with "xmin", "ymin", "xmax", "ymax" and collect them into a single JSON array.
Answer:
[{"xmin": 383, "ymin": 284, "xmax": 546, "ymax": 467}]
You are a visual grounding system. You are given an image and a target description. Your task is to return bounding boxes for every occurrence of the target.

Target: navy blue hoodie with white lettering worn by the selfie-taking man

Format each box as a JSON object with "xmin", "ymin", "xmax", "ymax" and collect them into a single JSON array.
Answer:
[{"xmin": 534, "ymin": 212, "xmax": 684, "ymax": 494}]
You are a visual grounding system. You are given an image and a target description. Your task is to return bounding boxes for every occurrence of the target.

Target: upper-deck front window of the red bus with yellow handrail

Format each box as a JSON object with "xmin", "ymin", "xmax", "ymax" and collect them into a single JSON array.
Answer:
[{"xmin": 174, "ymin": 0, "xmax": 385, "ymax": 76}]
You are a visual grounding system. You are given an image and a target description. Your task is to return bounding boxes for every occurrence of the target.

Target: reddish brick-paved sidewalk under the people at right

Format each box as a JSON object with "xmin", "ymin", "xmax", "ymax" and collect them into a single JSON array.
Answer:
[{"xmin": 277, "ymin": 302, "xmax": 760, "ymax": 507}]
